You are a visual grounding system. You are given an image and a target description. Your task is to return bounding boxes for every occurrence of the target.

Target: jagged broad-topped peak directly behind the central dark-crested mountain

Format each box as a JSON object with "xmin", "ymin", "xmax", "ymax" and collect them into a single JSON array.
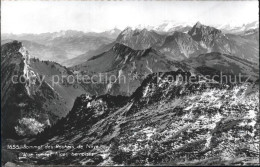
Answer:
[{"xmin": 116, "ymin": 27, "xmax": 165, "ymax": 50}]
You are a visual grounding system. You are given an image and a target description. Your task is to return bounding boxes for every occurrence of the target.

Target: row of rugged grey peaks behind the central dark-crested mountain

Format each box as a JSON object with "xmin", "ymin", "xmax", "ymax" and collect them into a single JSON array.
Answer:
[{"xmin": 66, "ymin": 22, "xmax": 259, "ymax": 67}]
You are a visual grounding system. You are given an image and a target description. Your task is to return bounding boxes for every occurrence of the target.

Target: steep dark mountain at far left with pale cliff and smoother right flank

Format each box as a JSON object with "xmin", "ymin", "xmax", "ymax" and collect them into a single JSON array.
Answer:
[{"xmin": 1, "ymin": 41, "xmax": 116, "ymax": 137}]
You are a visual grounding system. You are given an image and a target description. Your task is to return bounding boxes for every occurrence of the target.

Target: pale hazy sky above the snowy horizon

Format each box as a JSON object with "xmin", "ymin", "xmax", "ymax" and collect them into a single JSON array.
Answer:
[{"xmin": 1, "ymin": 1, "xmax": 258, "ymax": 33}]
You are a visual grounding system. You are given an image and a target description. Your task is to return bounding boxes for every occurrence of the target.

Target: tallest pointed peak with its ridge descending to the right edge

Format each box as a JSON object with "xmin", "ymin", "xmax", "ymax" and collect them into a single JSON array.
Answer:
[{"xmin": 188, "ymin": 22, "xmax": 259, "ymax": 61}]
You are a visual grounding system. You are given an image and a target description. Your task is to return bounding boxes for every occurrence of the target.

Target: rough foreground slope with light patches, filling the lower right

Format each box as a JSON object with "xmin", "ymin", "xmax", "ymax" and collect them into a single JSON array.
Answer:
[{"xmin": 16, "ymin": 70, "xmax": 259, "ymax": 165}]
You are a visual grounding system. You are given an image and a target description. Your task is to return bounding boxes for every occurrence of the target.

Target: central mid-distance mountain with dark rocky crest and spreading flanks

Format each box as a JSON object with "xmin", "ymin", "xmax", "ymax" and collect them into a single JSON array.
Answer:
[{"xmin": 71, "ymin": 43, "xmax": 185, "ymax": 95}]
